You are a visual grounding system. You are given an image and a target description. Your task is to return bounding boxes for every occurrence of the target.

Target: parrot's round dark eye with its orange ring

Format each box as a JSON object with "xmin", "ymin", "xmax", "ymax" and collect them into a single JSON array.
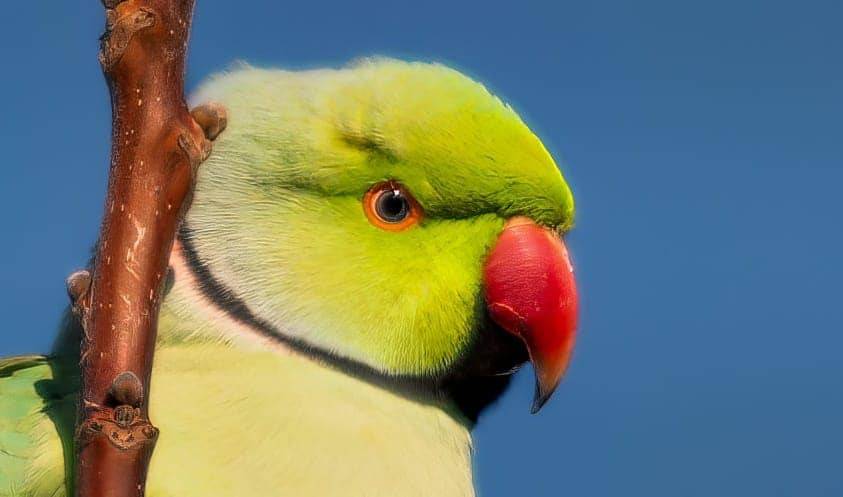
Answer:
[{"xmin": 363, "ymin": 181, "xmax": 423, "ymax": 231}]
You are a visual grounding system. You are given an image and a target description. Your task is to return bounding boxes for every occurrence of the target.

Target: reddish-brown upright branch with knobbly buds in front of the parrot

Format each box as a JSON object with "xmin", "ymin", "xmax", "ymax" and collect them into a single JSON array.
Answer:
[{"xmin": 68, "ymin": 0, "xmax": 225, "ymax": 497}]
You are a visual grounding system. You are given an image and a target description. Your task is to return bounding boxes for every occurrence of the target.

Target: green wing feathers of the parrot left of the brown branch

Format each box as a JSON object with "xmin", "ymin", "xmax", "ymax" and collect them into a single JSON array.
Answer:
[{"xmin": 0, "ymin": 355, "xmax": 78, "ymax": 497}]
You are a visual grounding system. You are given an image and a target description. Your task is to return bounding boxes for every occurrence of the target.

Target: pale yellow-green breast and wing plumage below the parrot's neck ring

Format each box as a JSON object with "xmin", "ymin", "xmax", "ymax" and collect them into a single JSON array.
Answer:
[{"xmin": 0, "ymin": 302, "xmax": 473, "ymax": 497}]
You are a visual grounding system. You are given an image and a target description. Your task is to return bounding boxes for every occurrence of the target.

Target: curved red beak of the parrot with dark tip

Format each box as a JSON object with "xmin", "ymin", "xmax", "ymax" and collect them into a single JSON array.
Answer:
[{"xmin": 484, "ymin": 217, "xmax": 578, "ymax": 413}]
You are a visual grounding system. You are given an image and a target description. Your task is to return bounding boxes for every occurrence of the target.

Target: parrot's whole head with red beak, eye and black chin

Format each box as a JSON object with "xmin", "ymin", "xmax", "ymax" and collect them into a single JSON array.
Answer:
[{"xmin": 181, "ymin": 59, "xmax": 577, "ymax": 418}]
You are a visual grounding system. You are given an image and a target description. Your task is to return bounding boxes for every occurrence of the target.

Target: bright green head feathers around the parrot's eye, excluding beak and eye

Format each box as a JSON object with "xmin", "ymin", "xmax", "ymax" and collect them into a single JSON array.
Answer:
[{"xmin": 186, "ymin": 59, "xmax": 574, "ymax": 375}]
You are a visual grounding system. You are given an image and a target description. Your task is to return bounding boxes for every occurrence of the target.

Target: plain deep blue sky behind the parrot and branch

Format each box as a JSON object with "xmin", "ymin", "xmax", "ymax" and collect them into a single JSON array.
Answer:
[{"xmin": 0, "ymin": 0, "xmax": 843, "ymax": 497}]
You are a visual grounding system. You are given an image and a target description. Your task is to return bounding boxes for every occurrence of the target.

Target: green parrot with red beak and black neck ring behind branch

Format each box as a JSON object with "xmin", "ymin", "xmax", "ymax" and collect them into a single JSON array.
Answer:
[{"xmin": 0, "ymin": 59, "xmax": 577, "ymax": 497}]
